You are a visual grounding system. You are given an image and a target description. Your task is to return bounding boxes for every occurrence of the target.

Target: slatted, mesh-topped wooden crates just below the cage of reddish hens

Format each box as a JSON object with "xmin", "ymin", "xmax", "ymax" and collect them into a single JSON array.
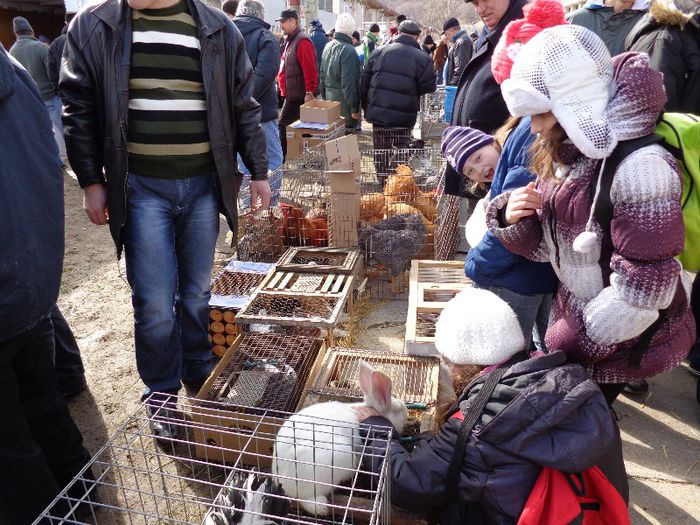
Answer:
[{"xmin": 238, "ymin": 248, "xmax": 361, "ymax": 344}]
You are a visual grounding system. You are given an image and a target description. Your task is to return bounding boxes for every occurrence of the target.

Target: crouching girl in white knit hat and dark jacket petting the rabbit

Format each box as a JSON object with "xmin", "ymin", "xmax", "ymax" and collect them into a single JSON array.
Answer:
[{"xmin": 352, "ymin": 288, "xmax": 629, "ymax": 525}]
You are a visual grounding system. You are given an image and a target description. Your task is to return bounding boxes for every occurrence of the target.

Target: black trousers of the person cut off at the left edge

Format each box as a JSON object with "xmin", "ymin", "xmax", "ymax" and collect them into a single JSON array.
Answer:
[{"xmin": 0, "ymin": 316, "xmax": 90, "ymax": 525}]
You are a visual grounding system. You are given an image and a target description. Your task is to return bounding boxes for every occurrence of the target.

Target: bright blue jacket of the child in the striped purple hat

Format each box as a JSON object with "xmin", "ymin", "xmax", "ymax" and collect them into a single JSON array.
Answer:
[{"xmin": 464, "ymin": 117, "xmax": 557, "ymax": 294}]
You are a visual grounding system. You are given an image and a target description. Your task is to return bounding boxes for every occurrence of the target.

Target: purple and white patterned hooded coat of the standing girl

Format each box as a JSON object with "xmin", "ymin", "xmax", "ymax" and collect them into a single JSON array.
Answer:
[{"xmin": 487, "ymin": 53, "xmax": 695, "ymax": 383}]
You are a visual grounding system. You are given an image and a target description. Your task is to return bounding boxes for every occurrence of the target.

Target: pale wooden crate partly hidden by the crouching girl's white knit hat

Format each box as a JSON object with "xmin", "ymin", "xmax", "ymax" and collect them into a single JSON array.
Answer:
[{"xmin": 404, "ymin": 260, "xmax": 471, "ymax": 355}]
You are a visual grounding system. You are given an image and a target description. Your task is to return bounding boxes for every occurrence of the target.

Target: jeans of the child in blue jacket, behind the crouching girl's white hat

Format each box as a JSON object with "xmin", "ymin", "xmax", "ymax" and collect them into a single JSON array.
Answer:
[{"xmin": 474, "ymin": 284, "xmax": 554, "ymax": 352}]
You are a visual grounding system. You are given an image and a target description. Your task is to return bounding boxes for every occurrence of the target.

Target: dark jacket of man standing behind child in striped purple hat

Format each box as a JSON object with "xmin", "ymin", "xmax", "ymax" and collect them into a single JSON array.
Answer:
[{"xmin": 445, "ymin": 0, "xmax": 527, "ymax": 195}]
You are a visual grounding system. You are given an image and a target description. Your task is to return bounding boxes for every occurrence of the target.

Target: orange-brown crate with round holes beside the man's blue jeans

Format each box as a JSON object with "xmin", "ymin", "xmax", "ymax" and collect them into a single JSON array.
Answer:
[{"xmin": 209, "ymin": 261, "xmax": 273, "ymax": 357}]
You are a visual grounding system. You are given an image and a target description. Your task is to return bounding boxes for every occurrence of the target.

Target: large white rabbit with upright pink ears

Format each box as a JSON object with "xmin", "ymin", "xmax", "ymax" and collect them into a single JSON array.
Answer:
[{"xmin": 272, "ymin": 361, "xmax": 408, "ymax": 516}]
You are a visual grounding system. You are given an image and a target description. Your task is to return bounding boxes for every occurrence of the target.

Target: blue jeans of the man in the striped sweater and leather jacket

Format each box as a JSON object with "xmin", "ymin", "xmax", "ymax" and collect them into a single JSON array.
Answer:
[{"xmin": 123, "ymin": 174, "xmax": 219, "ymax": 393}]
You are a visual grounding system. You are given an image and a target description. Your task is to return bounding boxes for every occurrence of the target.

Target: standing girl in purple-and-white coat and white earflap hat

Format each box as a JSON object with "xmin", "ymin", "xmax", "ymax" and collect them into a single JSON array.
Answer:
[{"xmin": 487, "ymin": 26, "xmax": 695, "ymax": 403}]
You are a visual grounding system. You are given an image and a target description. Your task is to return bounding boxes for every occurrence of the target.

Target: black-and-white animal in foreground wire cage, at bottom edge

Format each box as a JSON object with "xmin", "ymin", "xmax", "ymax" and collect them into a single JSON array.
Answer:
[{"xmin": 205, "ymin": 469, "xmax": 290, "ymax": 525}]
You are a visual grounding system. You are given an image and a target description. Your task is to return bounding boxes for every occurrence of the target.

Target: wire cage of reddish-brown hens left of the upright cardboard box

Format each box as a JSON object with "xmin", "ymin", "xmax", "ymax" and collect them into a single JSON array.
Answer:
[{"xmin": 236, "ymin": 148, "xmax": 329, "ymax": 262}]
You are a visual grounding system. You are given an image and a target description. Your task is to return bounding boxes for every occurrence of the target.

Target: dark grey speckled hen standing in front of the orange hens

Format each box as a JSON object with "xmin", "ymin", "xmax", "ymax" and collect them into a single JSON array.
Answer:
[{"xmin": 359, "ymin": 213, "xmax": 427, "ymax": 292}]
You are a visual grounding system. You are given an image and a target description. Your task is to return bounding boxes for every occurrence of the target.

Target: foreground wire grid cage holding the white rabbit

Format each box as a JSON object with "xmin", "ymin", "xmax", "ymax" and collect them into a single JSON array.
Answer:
[{"xmin": 34, "ymin": 396, "xmax": 391, "ymax": 525}]
